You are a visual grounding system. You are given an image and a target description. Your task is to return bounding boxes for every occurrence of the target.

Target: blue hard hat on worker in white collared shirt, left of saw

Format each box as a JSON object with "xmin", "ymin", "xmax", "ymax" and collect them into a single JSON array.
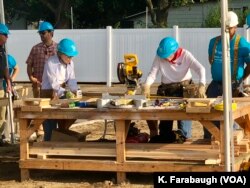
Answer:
[{"xmin": 57, "ymin": 38, "xmax": 78, "ymax": 57}]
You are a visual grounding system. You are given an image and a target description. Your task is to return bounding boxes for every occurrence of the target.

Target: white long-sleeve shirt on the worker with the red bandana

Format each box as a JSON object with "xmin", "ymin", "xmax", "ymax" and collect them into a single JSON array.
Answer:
[{"xmin": 145, "ymin": 49, "xmax": 206, "ymax": 85}]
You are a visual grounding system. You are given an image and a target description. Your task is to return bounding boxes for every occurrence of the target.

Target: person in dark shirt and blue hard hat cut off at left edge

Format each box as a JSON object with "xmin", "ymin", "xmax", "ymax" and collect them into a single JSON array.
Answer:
[{"xmin": 0, "ymin": 23, "xmax": 12, "ymax": 146}]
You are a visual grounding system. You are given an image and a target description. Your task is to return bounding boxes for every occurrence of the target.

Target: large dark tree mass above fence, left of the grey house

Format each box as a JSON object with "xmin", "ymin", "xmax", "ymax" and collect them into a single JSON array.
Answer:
[{"xmin": 5, "ymin": 0, "xmax": 146, "ymax": 29}]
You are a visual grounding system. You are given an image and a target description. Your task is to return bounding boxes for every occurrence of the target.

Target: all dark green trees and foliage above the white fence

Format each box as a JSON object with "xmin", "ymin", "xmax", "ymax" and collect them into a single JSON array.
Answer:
[{"xmin": 4, "ymin": 0, "xmax": 249, "ymax": 29}]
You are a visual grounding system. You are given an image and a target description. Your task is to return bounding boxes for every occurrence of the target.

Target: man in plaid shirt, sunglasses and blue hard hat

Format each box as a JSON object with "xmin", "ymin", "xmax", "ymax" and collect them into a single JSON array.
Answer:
[{"xmin": 26, "ymin": 21, "xmax": 57, "ymax": 141}]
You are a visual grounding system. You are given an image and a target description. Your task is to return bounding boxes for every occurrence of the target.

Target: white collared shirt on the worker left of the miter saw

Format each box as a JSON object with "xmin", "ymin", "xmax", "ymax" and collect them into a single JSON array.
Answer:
[{"xmin": 42, "ymin": 55, "xmax": 77, "ymax": 97}]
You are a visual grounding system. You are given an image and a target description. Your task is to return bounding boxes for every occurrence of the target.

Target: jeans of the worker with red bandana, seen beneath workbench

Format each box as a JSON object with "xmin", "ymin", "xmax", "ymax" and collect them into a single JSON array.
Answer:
[{"xmin": 159, "ymin": 120, "xmax": 192, "ymax": 138}]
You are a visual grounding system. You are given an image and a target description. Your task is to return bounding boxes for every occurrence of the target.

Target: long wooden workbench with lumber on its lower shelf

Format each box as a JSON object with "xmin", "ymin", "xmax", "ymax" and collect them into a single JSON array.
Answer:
[{"xmin": 15, "ymin": 99, "xmax": 250, "ymax": 183}]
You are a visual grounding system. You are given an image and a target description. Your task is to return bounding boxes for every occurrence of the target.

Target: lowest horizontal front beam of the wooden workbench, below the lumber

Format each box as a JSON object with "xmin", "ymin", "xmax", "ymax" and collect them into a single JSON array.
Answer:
[{"xmin": 20, "ymin": 159, "xmax": 225, "ymax": 173}]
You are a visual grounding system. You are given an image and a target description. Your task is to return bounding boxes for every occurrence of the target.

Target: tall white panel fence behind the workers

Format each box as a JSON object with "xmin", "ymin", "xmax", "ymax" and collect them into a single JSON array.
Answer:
[{"xmin": 7, "ymin": 26, "xmax": 250, "ymax": 86}]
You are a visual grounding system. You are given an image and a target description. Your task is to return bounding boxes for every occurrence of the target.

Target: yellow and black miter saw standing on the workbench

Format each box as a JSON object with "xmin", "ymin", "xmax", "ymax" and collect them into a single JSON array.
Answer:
[{"xmin": 117, "ymin": 54, "xmax": 142, "ymax": 95}]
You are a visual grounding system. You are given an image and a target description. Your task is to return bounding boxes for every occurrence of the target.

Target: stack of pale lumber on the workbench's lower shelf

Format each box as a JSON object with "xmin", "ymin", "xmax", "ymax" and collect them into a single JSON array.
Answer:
[{"xmin": 30, "ymin": 142, "xmax": 221, "ymax": 165}]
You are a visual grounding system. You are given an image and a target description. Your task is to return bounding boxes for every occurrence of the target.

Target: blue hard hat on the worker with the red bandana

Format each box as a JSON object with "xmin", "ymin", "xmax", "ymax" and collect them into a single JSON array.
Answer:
[{"xmin": 157, "ymin": 37, "xmax": 179, "ymax": 58}]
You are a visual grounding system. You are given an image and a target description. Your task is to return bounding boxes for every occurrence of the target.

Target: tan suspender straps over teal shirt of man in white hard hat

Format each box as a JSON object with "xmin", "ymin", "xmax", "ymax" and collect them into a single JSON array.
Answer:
[{"xmin": 209, "ymin": 35, "xmax": 240, "ymax": 80}]
